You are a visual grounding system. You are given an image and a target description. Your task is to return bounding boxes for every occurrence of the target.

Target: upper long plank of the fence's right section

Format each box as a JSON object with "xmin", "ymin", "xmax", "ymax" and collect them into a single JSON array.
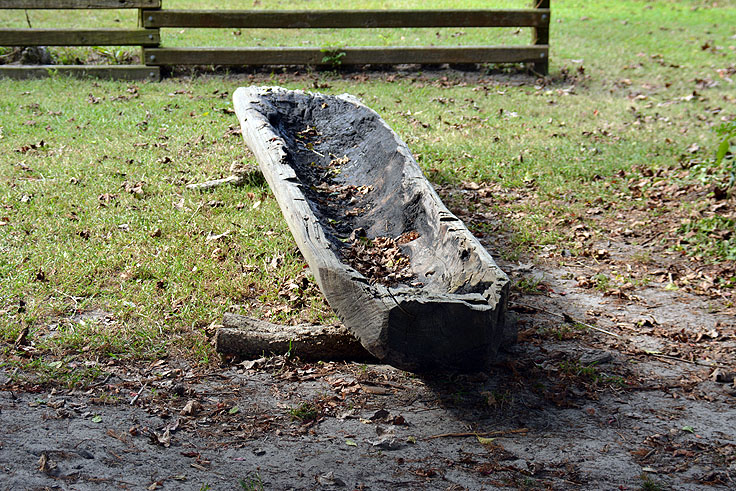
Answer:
[{"xmin": 142, "ymin": 9, "xmax": 549, "ymax": 28}]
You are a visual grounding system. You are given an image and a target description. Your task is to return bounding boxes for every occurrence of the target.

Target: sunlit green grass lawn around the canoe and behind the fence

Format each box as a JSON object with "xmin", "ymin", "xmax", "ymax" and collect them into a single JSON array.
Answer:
[{"xmin": 0, "ymin": 0, "xmax": 736, "ymax": 383}]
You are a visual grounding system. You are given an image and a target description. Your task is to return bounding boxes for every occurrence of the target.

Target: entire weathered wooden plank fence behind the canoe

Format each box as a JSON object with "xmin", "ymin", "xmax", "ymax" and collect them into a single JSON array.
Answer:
[{"xmin": 0, "ymin": 0, "xmax": 550, "ymax": 79}]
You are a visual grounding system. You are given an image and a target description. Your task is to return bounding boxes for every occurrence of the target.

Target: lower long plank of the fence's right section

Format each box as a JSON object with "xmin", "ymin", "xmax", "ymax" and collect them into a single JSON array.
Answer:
[{"xmin": 144, "ymin": 46, "xmax": 548, "ymax": 65}]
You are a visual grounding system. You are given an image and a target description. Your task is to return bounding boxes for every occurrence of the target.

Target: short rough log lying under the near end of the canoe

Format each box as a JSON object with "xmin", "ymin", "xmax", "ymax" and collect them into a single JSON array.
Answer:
[{"xmin": 215, "ymin": 314, "xmax": 373, "ymax": 361}]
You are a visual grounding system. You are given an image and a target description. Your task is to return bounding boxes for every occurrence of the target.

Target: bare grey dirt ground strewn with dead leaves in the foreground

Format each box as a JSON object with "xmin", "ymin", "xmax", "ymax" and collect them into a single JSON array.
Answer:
[{"xmin": 0, "ymin": 240, "xmax": 736, "ymax": 490}]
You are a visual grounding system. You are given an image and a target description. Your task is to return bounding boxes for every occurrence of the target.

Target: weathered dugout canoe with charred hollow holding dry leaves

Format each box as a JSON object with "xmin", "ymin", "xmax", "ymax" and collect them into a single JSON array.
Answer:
[{"xmin": 233, "ymin": 87, "xmax": 509, "ymax": 371}]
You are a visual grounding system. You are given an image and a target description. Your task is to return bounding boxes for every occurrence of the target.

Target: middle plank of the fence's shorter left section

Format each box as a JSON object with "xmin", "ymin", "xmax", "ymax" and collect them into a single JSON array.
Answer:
[{"xmin": 0, "ymin": 29, "xmax": 161, "ymax": 46}]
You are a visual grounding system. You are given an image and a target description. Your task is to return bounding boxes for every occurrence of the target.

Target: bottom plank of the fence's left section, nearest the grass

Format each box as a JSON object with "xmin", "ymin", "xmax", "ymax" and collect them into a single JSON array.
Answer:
[{"xmin": 0, "ymin": 65, "xmax": 161, "ymax": 81}]
